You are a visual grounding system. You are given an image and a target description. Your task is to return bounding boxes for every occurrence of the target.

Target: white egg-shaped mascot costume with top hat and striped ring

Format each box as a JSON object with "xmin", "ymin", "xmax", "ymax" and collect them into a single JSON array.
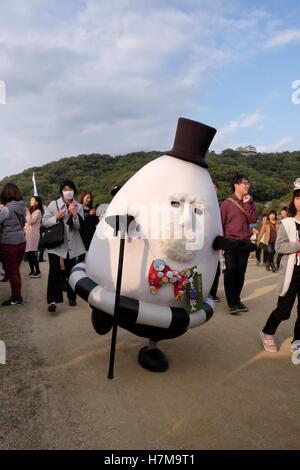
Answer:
[{"xmin": 70, "ymin": 118, "xmax": 252, "ymax": 372}]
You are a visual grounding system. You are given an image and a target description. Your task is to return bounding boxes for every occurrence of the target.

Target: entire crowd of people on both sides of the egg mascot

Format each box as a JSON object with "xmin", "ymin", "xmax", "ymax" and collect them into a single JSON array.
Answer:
[{"xmin": 0, "ymin": 174, "xmax": 300, "ymax": 362}]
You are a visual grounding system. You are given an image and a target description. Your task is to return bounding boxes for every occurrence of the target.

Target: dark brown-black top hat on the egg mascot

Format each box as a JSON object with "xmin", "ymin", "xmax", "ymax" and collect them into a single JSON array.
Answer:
[{"xmin": 166, "ymin": 118, "xmax": 217, "ymax": 168}]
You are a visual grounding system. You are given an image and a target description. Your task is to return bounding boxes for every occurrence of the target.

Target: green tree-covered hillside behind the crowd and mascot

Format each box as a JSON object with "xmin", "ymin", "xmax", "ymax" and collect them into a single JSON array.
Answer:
[{"xmin": 0, "ymin": 149, "xmax": 300, "ymax": 212}]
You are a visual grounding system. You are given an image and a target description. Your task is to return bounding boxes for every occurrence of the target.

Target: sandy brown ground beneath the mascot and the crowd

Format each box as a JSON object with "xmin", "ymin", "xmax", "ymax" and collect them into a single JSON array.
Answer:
[{"xmin": 0, "ymin": 260, "xmax": 300, "ymax": 450}]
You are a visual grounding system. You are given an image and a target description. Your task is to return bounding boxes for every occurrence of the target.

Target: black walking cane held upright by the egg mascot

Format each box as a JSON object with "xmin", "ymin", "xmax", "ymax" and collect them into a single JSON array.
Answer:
[{"xmin": 105, "ymin": 214, "xmax": 134, "ymax": 379}]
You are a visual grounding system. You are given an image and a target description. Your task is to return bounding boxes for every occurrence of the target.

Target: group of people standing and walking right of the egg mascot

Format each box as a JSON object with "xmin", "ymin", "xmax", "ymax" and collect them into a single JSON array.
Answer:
[{"xmin": 210, "ymin": 174, "xmax": 300, "ymax": 364}]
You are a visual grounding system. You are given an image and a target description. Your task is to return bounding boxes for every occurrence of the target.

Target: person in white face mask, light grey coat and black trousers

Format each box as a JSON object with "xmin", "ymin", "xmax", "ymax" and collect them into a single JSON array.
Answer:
[{"xmin": 42, "ymin": 180, "xmax": 85, "ymax": 312}]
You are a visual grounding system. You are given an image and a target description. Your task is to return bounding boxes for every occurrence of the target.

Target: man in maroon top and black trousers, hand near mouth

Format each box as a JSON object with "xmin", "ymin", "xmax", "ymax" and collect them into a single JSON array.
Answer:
[{"xmin": 221, "ymin": 174, "xmax": 257, "ymax": 315}]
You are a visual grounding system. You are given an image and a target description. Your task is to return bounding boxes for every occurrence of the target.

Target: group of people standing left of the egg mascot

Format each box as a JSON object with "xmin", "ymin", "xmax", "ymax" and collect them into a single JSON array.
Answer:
[{"xmin": 0, "ymin": 180, "xmax": 99, "ymax": 312}]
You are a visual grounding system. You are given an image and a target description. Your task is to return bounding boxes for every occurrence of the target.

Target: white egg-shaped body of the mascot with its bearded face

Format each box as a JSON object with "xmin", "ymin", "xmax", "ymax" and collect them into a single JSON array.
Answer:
[{"xmin": 86, "ymin": 155, "xmax": 222, "ymax": 307}]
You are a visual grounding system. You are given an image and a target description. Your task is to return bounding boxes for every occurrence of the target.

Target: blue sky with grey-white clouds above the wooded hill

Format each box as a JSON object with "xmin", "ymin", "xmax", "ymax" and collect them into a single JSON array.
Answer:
[{"xmin": 0, "ymin": 0, "xmax": 300, "ymax": 178}]
